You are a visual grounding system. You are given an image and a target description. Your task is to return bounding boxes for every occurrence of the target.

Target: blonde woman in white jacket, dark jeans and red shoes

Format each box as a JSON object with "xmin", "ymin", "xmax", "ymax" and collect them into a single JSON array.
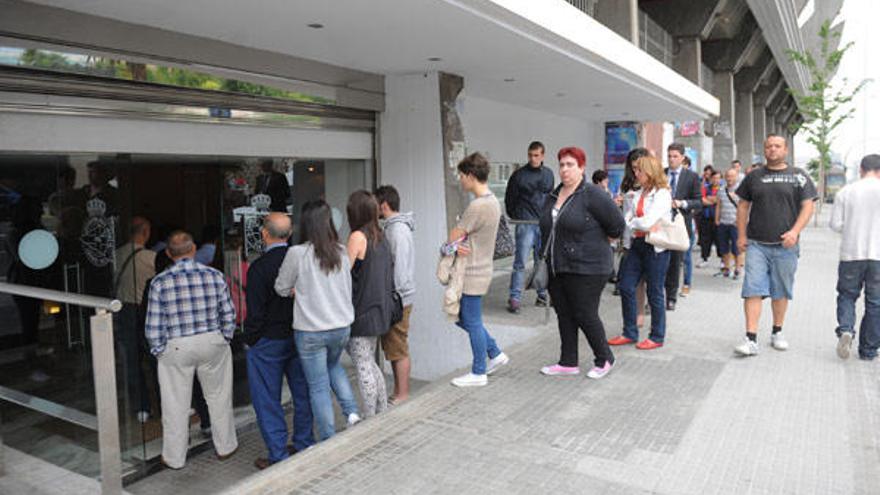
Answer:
[{"xmin": 608, "ymin": 156, "xmax": 672, "ymax": 350}]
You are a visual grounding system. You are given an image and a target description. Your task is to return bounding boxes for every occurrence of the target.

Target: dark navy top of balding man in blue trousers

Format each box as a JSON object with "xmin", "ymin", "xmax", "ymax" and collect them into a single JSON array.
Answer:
[{"xmin": 242, "ymin": 247, "xmax": 293, "ymax": 345}]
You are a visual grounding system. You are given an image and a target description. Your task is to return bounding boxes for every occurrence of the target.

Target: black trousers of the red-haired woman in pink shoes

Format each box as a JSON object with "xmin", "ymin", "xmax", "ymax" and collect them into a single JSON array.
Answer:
[{"xmin": 549, "ymin": 273, "xmax": 614, "ymax": 366}]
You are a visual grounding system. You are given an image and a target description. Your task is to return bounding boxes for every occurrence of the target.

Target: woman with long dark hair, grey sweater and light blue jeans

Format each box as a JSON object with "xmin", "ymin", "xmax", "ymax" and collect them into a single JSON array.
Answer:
[{"xmin": 275, "ymin": 200, "xmax": 360, "ymax": 440}]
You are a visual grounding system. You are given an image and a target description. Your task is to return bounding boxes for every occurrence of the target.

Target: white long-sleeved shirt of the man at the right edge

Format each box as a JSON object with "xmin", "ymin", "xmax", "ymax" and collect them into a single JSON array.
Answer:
[{"xmin": 831, "ymin": 177, "xmax": 880, "ymax": 261}]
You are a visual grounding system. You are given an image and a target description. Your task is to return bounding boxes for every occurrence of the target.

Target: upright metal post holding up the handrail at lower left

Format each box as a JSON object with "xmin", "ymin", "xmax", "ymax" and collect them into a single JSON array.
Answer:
[{"xmin": 91, "ymin": 309, "xmax": 122, "ymax": 495}]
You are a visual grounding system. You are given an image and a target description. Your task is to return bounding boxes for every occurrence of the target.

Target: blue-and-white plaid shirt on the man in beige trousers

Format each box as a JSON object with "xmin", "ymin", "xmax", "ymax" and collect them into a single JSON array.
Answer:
[{"xmin": 145, "ymin": 258, "xmax": 235, "ymax": 356}]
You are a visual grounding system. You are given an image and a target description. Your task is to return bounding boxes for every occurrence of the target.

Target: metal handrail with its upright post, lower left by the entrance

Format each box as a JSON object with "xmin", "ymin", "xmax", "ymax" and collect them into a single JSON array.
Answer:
[{"xmin": 0, "ymin": 282, "xmax": 122, "ymax": 495}]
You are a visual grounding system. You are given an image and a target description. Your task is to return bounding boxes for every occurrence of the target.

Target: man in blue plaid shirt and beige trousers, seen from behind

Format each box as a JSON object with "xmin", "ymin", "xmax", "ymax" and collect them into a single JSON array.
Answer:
[{"xmin": 146, "ymin": 231, "xmax": 238, "ymax": 469}]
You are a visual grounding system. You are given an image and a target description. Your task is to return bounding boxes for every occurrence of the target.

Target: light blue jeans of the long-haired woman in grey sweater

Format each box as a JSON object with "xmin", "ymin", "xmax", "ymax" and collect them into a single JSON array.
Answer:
[{"xmin": 293, "ymin": 327, "xmax": 358, "ymax": 441}]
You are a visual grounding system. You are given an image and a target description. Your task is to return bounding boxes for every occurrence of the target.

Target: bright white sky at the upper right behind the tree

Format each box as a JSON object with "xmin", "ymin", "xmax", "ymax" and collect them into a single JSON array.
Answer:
[{"xmin": 795, "ymin": 0, "xmax": 880, "ymax": 173}]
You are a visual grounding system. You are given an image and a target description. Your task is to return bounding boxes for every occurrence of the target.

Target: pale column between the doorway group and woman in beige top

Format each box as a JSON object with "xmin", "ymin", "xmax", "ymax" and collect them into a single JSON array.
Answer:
[{"xmin": 379, "ymin": 72, "xmax": 454, "ymax": 380}]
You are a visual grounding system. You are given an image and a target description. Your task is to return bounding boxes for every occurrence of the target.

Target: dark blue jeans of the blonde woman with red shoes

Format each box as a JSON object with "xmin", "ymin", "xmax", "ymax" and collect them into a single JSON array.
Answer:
[{"xmin": 618, "ymin": 237, "xmax": 670, "ymax": 344}]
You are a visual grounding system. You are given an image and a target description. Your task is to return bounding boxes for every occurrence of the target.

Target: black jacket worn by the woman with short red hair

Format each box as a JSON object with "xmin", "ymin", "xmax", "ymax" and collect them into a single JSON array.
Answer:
[{"xmin": 540, "ymin": 181, "xmax": 626, "ymax": 275}]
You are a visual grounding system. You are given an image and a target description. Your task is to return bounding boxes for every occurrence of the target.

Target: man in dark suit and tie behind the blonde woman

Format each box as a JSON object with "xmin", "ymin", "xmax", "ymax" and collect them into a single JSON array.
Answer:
[{"xmin": 666, "ymin": 143, "xmax": 703, "ymax": 311}]
